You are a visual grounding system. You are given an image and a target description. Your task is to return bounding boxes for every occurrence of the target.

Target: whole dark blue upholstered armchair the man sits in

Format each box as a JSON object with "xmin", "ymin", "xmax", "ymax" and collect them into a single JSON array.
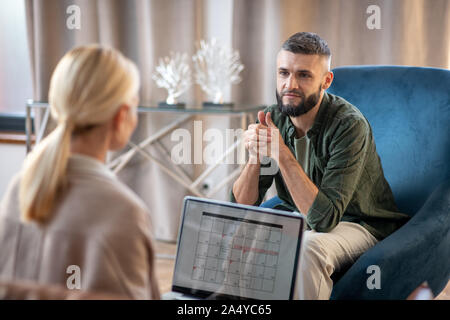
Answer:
[{"xmin": 263, "ymin": 66, "xmax": 450, "ymax": 299}]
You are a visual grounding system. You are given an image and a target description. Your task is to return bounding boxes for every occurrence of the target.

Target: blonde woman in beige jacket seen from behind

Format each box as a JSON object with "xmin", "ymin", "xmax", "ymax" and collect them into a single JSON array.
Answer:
[{"xmin": 0, "ymin": 46, "xmax": 159, "ymax": 299}]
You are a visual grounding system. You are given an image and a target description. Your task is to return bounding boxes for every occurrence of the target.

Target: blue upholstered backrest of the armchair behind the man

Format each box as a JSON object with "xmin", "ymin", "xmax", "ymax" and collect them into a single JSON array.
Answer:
[{"xmin": 328, "ymin": 66, "xmax": 450, "ymax": 216}]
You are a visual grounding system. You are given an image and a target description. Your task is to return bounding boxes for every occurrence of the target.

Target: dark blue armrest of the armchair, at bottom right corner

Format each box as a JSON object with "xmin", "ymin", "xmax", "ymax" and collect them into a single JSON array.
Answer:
[{"xmin": 331, "ymin": 180, "xmax": 450, "ymax": 299}]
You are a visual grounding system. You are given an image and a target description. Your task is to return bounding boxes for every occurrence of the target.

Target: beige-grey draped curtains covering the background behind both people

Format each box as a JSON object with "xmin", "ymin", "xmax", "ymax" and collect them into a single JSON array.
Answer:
[{"xmin": 26, "ymin": 0, "xmax": 450, "ymax": 241}]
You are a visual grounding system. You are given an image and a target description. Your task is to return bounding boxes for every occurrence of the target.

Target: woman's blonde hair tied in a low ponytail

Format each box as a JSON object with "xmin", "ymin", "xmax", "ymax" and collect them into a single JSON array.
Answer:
[{"xmin": 19, "ymin": 45, "xmax": 139, "ymax": 223}]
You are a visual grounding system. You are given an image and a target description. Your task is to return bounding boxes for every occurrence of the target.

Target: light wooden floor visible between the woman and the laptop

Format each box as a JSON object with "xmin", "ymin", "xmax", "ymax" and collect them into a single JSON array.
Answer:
[{"xmin": 156, "ymin": 241, "xmax": 450, "ymax": 300}]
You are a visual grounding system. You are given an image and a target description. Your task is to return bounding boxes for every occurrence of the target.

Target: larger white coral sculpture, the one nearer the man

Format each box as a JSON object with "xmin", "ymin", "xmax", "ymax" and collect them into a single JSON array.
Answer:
[{"xmin": 192, "ymin": 38, "xmax": 244, "ymax": 104}]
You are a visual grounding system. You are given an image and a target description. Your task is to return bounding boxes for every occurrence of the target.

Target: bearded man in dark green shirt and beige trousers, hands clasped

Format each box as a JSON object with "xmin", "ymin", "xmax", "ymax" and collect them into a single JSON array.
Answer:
[{"xmin": 231, "ymin": 32, "xmax": 408, "ymax": 299}]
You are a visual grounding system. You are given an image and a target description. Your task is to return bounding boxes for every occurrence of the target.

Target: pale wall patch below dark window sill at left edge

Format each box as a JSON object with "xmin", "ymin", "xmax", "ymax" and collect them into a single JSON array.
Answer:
[{"xmin": 0, "ymin": 143, "xmax": 26, "ymax": 198}]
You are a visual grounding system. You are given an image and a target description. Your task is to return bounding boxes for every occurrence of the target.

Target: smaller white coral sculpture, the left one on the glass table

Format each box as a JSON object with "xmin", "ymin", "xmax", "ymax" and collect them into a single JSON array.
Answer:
[{"xmin": 152, "ymin": 52, "xmax": 192, "ymax": 104}]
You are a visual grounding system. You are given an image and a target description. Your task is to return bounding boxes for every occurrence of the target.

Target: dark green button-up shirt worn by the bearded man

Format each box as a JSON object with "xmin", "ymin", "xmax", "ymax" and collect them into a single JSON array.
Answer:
[{"xmin": 231, "ymin": 92, "xmax": 409, "ymax": 240}]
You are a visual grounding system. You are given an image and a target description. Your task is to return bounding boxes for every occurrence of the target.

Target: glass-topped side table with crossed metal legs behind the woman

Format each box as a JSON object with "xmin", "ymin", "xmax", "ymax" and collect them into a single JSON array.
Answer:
[{"xmin": 25, "ymin": 100, "xmax": 265, "ymax": 198}]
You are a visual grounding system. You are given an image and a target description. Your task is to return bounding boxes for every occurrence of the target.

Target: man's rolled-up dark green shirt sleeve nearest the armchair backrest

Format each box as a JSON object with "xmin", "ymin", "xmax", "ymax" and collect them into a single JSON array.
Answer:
[{"xmin": 306, "ymin": 117, "xmax": 370, "ymax": 232}]
